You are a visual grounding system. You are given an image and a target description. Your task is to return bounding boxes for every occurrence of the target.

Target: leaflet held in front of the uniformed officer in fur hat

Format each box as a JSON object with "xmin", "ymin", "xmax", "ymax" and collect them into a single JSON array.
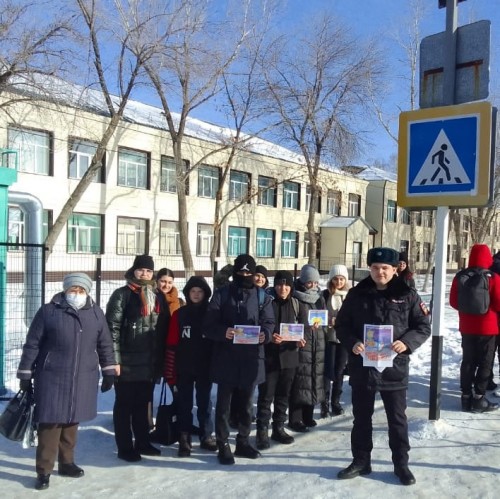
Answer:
[{"xmin": 361, "ymin": 324, "xmax": 397, "ymax": 372}]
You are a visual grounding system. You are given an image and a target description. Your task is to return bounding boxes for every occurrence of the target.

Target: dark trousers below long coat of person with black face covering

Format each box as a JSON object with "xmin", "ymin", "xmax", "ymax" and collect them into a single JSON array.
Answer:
[{"xmin": 215, "ymin": 384, "xmax": 255, "ymax": 443}]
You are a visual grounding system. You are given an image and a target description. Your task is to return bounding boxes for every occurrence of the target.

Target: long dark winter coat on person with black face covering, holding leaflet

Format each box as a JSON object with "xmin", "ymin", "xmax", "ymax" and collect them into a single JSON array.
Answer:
[{"xmin": 205, "ymin": 283, "xmax": 275, "ymax": 388}]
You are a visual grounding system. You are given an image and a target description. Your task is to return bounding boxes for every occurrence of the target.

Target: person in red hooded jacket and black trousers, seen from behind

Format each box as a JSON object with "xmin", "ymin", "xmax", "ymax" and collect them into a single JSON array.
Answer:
[{"xmin": 450, "ymin": 244, "xmax": 500, "ymax": 412}]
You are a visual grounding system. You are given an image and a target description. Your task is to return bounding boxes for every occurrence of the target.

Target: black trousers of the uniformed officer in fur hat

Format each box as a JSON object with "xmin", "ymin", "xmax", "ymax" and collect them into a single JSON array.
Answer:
[{"xmin": 351, "ymin": 386, "xmax": 410, "ymax": 466}]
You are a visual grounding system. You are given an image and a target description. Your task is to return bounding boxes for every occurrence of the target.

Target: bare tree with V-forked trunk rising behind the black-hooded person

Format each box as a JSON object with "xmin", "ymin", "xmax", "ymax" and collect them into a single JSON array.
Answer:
[{"xmin": 145, "ymin": 0, "xmax": 251, "ymax": 274}]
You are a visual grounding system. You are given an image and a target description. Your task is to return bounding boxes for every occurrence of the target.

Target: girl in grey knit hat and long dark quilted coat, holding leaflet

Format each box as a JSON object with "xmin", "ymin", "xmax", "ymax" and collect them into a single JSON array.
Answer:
[{"xmin": 289, "ymin": 265, "xmax": 326, "ymax": 432}]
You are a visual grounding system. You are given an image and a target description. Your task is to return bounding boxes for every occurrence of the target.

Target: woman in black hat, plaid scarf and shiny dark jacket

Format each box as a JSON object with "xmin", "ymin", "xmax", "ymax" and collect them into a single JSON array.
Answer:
[{"xmin": 106, "ymin": 255, "xmax": 165, "ymax": 462}]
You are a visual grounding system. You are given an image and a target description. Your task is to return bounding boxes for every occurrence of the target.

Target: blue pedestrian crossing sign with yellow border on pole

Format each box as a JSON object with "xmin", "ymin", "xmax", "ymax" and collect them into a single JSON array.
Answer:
[{"xmin": 398, "ymin": 102, "xmax": 494, "ymax": 207}]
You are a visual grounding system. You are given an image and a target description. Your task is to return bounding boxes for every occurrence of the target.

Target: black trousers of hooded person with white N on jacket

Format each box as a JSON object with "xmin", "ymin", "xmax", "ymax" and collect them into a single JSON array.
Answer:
[{"xmin": 177, "ymin": 374, "xmax": 214, "ymax": 438}]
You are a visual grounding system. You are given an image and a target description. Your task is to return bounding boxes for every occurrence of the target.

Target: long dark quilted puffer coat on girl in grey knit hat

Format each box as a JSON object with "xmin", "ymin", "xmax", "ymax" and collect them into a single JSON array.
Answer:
[{"xmin": 290, "ymin": 280, "xmax": 326, "ymax": 406}]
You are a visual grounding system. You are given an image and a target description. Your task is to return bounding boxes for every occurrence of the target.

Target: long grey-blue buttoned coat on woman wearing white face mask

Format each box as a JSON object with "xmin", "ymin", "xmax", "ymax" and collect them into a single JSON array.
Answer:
[{"xmin": 17, "ymin": 293, "xmax": 115, "ymax": 423}]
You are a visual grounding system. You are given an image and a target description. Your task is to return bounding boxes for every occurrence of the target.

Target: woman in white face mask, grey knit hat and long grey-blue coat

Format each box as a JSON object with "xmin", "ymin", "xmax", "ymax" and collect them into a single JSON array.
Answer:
[{"xmin": 17, "ymin": 273, "xmax": 116, "ymax": 490}]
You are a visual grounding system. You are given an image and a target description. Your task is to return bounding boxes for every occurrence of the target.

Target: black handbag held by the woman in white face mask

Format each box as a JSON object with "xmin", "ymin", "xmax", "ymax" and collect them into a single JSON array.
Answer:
[{"xmin": 0, "ymin": 390, "xmax": 33, "ymax": 442}]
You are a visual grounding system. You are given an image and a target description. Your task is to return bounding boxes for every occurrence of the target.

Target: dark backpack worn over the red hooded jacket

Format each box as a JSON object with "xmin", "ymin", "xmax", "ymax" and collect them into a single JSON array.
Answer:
[{"xmin": 455, "ymin": 267, "xmax": 492, "ymax": 315}]
